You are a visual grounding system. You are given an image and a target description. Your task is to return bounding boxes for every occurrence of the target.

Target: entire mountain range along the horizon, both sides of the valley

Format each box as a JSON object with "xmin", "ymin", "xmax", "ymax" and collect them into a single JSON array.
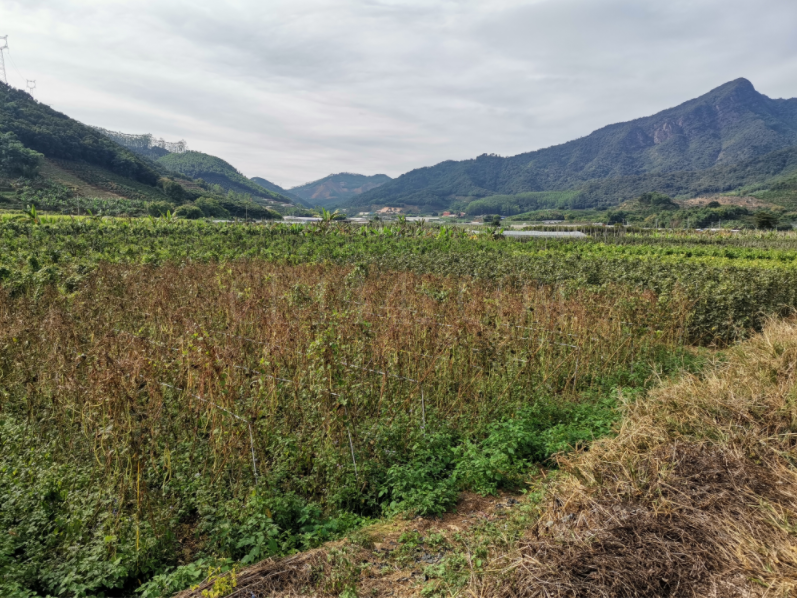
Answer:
[{"xmin": 0, "ymin": 79, "xmax": 797, "ymax": 215}]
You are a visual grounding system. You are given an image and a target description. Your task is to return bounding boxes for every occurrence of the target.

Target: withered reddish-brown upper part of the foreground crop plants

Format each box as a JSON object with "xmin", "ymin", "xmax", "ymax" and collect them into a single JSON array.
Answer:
[{"xmin": 0, "ymin": 262, "xmax": 685, "ymax": 496}]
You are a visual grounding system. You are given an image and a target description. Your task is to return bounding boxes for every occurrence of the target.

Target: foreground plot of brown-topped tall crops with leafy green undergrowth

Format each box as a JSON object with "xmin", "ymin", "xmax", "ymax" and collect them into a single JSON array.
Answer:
[{"xmin": 0, "ymin": 261, "xmax": 690, "ymax": 593}]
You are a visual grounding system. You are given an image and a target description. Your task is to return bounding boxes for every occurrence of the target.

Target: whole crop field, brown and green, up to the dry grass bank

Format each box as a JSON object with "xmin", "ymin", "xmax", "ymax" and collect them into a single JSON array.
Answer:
[{"xmin": 0, "ymin": 218, "xmax": 797, "ymax": 598}]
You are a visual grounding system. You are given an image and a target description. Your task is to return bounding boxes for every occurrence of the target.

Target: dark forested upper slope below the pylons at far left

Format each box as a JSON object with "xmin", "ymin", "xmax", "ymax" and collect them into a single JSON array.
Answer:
[{"xmin": 0, "ymin": 83, "xmax": 159, "ymax": 186}]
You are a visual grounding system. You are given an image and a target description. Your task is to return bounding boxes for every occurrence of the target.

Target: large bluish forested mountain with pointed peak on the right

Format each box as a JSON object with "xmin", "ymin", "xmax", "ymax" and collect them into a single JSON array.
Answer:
[{"xmin": 349, "ymin": 79, "xmax": 797, "ymax": 212}]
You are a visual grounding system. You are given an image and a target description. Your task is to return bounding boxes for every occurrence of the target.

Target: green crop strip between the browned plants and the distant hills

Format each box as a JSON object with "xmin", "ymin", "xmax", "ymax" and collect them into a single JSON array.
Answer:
[{"xmin": 0, "ymin": 220, "xmax": 797, "ymax": 342}]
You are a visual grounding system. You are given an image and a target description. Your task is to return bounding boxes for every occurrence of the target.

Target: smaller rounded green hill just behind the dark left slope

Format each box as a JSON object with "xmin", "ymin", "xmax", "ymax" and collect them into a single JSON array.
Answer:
[{"xmin": 157, "ymin": 151, "xmax": 292, "ymax": 203}]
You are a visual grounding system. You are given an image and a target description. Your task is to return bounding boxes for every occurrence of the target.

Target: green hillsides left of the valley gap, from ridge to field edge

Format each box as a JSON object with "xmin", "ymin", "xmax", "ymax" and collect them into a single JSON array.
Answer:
[{"xmin": 0, "ymin": 84, "xmax": 288, "ymax": 219}]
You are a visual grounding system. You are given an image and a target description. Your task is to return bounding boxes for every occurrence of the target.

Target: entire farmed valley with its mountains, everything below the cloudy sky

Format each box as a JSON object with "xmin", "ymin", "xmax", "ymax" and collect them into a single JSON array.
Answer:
[{"xmin": 0, "ymin": 79, "xmax": 797, "ymax": 598}]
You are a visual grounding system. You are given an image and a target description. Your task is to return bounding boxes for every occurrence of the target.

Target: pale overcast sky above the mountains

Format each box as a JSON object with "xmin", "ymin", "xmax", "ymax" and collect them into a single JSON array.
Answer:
[{"xmin": 0, "ymin": 0, "xmax": 797, "ymax": 188}]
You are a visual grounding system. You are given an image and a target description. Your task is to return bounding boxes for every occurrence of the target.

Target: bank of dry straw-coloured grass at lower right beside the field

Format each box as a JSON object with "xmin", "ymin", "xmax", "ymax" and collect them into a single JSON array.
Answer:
[{"xmin": 494, "ymin": 321, "xmax": 797, "ymax": 598}]
